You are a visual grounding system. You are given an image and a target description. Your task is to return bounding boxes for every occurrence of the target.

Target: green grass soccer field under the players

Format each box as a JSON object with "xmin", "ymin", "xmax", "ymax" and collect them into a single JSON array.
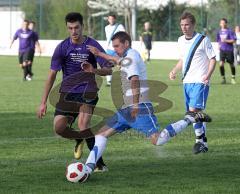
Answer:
[{"xmin": 0, "ymin": 56, "xmax": 240, "ymax": 194}]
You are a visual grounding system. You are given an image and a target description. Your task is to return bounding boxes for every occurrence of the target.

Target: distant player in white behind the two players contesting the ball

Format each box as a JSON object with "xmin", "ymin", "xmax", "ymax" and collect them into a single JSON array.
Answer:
[{"xmin": 105, "ymin": 14, "xmax": 125, "ymax": 86}]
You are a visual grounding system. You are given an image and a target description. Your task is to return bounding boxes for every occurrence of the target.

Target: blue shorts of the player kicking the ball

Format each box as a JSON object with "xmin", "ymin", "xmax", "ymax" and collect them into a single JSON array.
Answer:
[{"xmin": 107, "ymin": 103, "xmax": 159, "ymax": 137}]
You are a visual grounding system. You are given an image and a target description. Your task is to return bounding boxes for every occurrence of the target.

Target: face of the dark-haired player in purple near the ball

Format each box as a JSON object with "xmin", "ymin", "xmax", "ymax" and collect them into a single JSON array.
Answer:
[{"xmin": 67, "ymin": 21, "xmax": 83, "ymax": 42}]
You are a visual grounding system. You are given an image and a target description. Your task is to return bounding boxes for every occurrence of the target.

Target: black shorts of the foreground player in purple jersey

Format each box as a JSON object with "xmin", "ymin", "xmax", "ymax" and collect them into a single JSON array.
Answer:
[{"xmin": 54, "ymin": 93, "xmax": 98, "ymax": 120}]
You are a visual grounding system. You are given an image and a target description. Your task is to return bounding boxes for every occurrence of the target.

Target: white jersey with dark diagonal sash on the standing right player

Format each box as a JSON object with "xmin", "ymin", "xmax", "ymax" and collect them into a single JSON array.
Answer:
[{"xmin": 178, "ymin": 33, "xmax": 216, "ymax": 83}]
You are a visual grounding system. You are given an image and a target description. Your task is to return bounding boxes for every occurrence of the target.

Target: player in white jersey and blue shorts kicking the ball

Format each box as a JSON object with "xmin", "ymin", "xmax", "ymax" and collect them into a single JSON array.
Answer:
[{"xmin": 82, "ymin": 32, "xmax": 212, "ymax": 176}]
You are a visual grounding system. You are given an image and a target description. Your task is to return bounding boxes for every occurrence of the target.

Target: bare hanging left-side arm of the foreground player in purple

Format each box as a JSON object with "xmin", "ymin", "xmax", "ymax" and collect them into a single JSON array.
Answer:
[{"xmin": 37, "ymin": 70, "xmax": 57, "ymax": 119}]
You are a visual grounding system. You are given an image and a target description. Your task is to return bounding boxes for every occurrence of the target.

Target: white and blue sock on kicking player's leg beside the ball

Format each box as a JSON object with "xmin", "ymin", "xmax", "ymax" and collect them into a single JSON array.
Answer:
[{"xmin": 86, "ymin": 135, "xmax": 107, "ymax": 173}]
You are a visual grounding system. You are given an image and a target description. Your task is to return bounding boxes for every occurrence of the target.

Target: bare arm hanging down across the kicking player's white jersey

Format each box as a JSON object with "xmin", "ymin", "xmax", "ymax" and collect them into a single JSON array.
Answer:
[{"xmin": 130, "ymin": 75, "xmax": 140, "ymax": 118}]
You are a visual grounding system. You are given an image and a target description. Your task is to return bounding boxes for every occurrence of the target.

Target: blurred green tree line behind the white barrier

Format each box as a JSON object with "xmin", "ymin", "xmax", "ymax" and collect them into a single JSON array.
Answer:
[{"xmin": 20, "ymin": 0, "xmax": 240, "ymax": 41}]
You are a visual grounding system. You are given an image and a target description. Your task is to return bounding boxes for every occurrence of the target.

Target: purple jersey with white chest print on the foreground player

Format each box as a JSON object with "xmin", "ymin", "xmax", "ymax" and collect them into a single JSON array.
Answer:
[{"xmin": 50, "ymin": 37, "xmax": 111, "ymax": 93}]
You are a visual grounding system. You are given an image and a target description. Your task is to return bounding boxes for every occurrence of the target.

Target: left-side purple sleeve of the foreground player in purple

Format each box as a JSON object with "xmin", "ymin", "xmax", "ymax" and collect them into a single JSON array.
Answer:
[{"xmin": 50, "ymin": 45, "xmax": 63, "ymax": 71}]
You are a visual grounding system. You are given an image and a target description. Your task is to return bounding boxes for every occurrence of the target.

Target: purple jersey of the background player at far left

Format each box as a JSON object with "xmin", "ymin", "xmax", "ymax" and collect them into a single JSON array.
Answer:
[{"xmin": 13, "ymin": 29, "xmax": 35, "ymax": 53}]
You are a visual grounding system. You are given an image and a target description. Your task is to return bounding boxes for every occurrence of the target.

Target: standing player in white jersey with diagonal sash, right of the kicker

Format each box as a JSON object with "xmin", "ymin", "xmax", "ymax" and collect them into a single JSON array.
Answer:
[{"xmin": 169, "ymin": 12, "xmax": 216, "ymax": 154}]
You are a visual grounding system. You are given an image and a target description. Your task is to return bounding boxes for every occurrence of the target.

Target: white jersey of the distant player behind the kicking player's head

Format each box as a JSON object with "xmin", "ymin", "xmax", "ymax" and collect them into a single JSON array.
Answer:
[{"xmin": 105, "ymin": 23, "xmax": 125, "ymax": 50}]
